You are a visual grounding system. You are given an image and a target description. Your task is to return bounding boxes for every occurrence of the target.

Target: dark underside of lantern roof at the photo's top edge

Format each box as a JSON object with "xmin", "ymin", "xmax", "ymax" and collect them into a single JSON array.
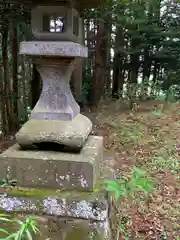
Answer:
[{"xmin": 11, "ymin": 0, "xmax": 106, "ymax": 9}]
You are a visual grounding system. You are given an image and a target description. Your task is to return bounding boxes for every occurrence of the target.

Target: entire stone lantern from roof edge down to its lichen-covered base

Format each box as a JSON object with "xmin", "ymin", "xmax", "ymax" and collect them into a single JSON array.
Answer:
[{"xmin": 0, "ymin": 0, "xmax": 112, "ymax": 240}]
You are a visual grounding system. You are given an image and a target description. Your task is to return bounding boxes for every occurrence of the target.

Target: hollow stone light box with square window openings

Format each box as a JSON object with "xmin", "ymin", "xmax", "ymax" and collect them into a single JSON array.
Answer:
[{"xmin": 31, "ymin": 4, "xmax": 82, "ymax": 43}]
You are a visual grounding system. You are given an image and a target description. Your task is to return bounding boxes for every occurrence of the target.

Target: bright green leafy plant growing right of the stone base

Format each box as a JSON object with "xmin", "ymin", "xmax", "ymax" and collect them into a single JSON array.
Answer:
[{"xmin": 105, "ymin": 167, "xmax": 154, "ymax": 201}]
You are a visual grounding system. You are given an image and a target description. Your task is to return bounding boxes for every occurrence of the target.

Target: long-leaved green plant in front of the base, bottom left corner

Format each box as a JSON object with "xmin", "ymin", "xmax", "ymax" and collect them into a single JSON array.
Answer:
[{"xmin": 0, "ymin": 214, "xmax": 40, "ymax": 240}]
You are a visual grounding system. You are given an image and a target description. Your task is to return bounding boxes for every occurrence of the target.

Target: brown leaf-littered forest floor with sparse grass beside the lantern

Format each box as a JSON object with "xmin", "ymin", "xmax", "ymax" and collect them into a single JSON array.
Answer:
[{"xmin": 0, "ymin": 101, "xmax": 180, "ymax": 240}]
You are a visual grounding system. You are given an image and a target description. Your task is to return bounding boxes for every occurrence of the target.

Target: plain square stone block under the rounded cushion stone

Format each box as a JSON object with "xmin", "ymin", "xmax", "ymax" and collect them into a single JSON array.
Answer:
[{"xmin": 0, "ymin": 136, "xmax": 103, "ymax": 190}]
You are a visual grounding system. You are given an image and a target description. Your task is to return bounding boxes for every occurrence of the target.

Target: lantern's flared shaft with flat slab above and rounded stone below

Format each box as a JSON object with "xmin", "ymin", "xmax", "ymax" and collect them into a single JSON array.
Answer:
[{"xmin": 16, "ymin": 42, "xmax": 92, "ymax": 150}]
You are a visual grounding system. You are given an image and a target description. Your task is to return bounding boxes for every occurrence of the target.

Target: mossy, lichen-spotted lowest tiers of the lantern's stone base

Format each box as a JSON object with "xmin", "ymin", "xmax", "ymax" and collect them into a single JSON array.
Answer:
[{"xmin": 0, "ymin": 163, "xmax": 114, "ymax": 240}]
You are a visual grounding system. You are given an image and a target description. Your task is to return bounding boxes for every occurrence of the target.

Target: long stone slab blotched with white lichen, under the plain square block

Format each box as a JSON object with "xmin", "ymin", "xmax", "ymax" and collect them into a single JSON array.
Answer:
[{"xmin": 0, "ymin": 193, "xmax": 108, "ymax": 221}]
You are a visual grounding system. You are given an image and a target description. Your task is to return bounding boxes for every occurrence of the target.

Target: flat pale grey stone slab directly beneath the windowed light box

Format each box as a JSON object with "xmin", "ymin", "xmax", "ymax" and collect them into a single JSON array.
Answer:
[{"xmin": 19, "ymin": 41, "xmax": 88, "ymax": 58}]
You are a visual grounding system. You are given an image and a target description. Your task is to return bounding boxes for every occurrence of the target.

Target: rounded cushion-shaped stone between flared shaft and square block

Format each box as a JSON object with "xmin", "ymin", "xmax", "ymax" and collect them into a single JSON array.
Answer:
[{"xmin": 16, "ymin": 114, "xmax": 92, "ymax": 149}]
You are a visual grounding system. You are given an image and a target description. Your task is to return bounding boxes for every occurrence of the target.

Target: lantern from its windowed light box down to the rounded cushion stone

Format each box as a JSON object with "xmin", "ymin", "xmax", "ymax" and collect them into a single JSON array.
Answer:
[{"xmin": 16, "ymin": 1, "xmax": 92, "ymax": 149}]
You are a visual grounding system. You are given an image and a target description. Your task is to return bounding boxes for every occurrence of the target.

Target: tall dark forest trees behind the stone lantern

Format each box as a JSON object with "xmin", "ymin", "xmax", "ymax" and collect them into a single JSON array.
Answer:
[{"xmin": 0, "ymin": 0, "xmax": 180, "ymax": 134}]
